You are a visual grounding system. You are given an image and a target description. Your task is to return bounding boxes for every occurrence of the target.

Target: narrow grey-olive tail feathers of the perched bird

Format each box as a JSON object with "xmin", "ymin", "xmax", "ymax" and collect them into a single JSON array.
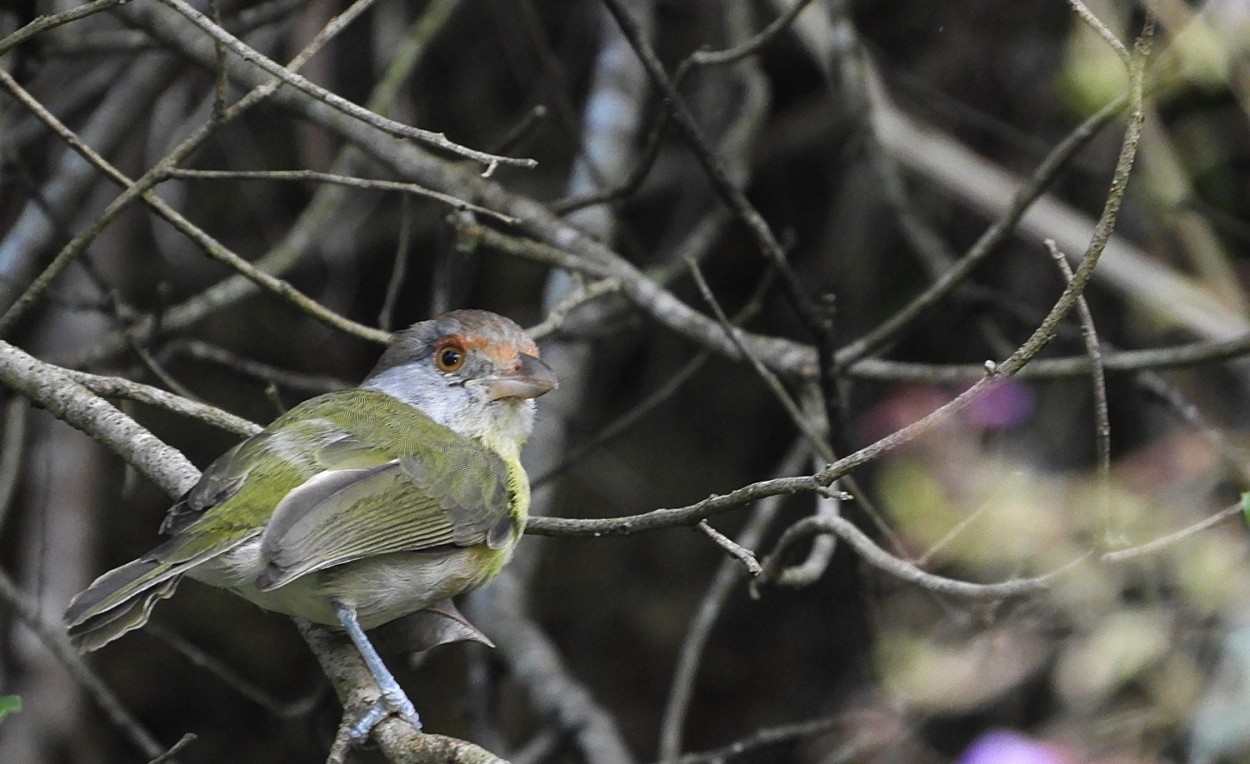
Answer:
[{"xmin": 65, "ymin": 539, "xmax": 215, "ymax": 650}]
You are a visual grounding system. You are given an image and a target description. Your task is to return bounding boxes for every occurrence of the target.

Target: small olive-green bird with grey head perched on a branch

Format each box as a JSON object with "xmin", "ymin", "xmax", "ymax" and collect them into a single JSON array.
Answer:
[{"xmin": 65, "ymin": 310, "xmax": 556, "ymax": 739}]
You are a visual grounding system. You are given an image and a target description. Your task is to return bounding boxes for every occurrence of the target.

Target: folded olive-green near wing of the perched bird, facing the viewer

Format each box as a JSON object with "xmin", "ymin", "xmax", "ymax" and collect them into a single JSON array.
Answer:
[{"xmin": 258, "ymin": 425, "xmax": 519, "ymax": 590}]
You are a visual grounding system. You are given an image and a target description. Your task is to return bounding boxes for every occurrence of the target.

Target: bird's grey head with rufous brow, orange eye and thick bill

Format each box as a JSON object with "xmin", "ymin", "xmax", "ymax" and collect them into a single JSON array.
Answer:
[{"xmin": 361, "ymin": 310, "xmax": 556, "ymax": 450}]
